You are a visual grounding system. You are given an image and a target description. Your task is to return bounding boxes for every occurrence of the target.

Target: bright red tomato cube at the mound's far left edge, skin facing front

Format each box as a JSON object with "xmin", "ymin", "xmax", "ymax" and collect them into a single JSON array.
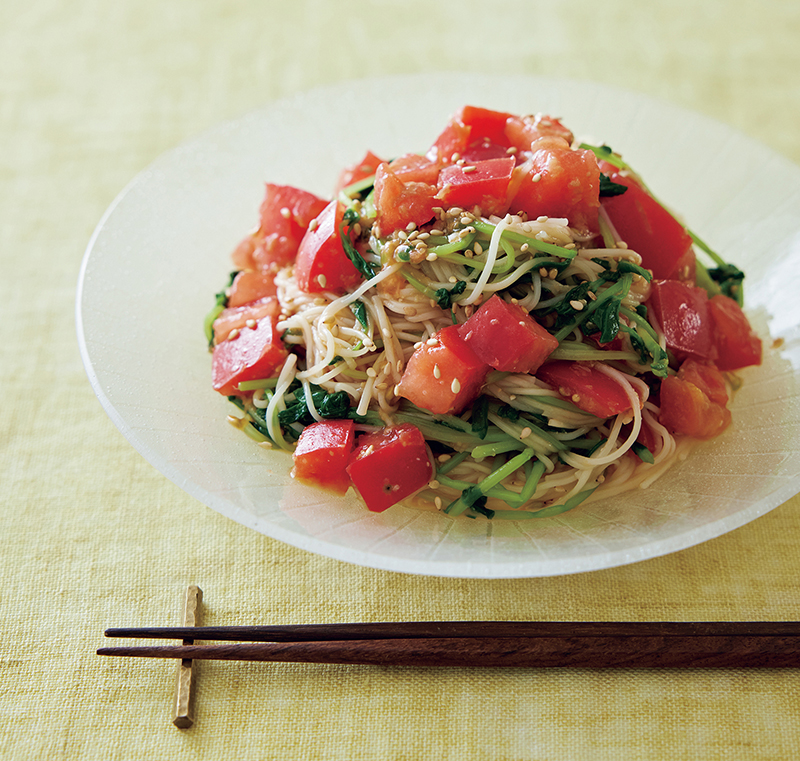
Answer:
[{"xmin": 211, "ymin": 315, "xmax": 288, "ymax": 396}]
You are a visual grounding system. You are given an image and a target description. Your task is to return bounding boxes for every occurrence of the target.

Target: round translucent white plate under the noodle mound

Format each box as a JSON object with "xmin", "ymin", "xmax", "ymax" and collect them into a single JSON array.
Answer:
[{"xmin": 77, "ymin": 74, "xmax": 800, "ymax": 578}]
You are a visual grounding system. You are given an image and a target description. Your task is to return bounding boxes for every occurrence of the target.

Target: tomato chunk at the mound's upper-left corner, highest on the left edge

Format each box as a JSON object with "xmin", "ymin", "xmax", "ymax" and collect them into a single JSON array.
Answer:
[{"xmin": 252, "ymin": 184, "xmax": 328, "ymax": 269}]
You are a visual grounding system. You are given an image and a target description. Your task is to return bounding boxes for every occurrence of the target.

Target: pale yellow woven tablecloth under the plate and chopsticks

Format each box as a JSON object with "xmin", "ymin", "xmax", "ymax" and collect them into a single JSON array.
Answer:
[{"xmin": 6, "ymin": 0, "xmax": 800, "ymax": 761}]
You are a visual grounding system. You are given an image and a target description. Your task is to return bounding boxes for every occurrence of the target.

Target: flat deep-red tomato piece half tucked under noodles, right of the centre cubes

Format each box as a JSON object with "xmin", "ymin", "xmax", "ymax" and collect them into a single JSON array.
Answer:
[{"xmin": 536, "ymin": 359, "xmax": 632, "ymax": 418}]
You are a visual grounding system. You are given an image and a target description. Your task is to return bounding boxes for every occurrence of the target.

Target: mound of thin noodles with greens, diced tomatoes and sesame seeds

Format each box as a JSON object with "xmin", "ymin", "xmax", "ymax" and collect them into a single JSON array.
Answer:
[{"xmin": 205, "ymin": 106, "xmax": 761, "ymax": 520}]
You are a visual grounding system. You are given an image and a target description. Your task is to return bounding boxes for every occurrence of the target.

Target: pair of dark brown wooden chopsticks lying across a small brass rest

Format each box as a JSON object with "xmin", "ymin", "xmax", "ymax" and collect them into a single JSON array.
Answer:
[{"xmin": 97, "ymin": 621, "xmax": 800, "ymax": 668}]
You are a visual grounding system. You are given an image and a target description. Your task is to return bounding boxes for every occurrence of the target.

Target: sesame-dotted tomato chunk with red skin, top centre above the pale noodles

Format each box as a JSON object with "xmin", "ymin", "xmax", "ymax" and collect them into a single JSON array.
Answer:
[{"xmin": 436, "ymin": 157, "xmax": 514, "ymax": 216}]
